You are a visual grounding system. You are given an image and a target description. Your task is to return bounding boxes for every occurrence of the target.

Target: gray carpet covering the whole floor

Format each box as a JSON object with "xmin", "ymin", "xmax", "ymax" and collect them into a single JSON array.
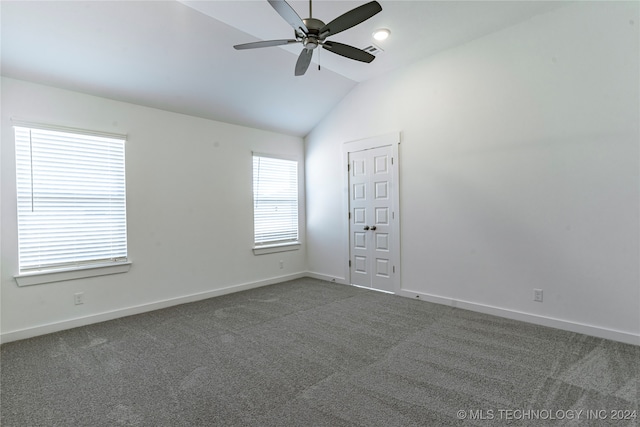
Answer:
[{"xmin": 0, "ymin": 279, "xmax": 640, "ymax": 427}]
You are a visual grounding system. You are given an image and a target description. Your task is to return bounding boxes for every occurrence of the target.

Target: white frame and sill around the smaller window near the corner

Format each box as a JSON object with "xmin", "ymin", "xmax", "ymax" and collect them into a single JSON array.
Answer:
[{"xmin": 251, "ymin": 151, "xmax": 302, "ymax": 255}]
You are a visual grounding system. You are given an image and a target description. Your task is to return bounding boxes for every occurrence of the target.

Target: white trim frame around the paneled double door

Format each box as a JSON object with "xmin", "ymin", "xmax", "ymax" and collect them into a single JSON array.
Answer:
[{"xmin": 342, "ymin": 132, "xmax": 402, "ymax": 294}]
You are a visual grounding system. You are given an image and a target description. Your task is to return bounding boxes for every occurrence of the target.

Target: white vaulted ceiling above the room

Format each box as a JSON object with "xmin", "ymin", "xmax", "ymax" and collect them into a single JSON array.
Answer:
[{"xmin": 0, "ymin": 0, "xmax": 561, "ymax": 136}]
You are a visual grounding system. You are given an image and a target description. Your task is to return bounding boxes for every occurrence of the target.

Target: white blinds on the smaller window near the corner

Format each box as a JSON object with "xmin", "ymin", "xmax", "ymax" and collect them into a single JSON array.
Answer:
[{"xmin": 253, "ymin": 154, "xmax": 298, "ymax": 246}]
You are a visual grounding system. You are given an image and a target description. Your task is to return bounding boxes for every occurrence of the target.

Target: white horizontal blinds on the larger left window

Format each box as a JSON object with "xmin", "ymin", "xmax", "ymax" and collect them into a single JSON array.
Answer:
[{"xmin": 14, "ymin": 126, "xmax": 127, "ymax": 273}]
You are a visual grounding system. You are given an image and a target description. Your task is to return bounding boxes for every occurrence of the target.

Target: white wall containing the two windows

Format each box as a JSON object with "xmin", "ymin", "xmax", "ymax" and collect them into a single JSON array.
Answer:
[{"xmin": 0, "ymin": 78, "xmax": 306, "ymax": 341}]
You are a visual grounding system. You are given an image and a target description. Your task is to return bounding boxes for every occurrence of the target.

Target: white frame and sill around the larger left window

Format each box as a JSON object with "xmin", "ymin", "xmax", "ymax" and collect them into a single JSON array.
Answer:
[{"xmin": 12, "ymin": 119, "xmax": 131, "ymax": 286}]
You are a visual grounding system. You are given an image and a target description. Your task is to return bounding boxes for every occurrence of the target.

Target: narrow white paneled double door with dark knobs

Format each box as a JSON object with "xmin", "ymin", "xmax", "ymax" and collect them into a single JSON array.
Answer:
[{"xmin": 348, "ymin": 146, "xmax": 397, "ymax": 292}]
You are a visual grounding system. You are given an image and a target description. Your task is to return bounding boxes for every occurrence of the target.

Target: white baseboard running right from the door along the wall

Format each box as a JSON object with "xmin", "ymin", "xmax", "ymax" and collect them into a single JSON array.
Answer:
[{"xmin": 397, "ymin": 289, "xmax": 640, "ymax": 345}]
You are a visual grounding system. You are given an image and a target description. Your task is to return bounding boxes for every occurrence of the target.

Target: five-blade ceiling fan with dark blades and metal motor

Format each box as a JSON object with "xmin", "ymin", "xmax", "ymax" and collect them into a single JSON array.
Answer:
[{"xmin": 234, "ymin": 0, "xmax": 382, "ymax": 76}]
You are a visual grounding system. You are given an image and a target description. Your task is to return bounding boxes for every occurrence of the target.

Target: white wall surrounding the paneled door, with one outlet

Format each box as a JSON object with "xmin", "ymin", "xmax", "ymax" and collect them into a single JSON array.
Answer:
[{"xmin": 306, "ymin": 2, "xmax": 640, "ymax": 343}]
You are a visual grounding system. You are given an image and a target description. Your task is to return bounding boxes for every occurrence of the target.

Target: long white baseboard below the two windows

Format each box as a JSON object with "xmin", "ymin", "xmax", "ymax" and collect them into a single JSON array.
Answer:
[{"xmin": 0, "ymin": 272, "xmax": 307, "ymax": 344}]
